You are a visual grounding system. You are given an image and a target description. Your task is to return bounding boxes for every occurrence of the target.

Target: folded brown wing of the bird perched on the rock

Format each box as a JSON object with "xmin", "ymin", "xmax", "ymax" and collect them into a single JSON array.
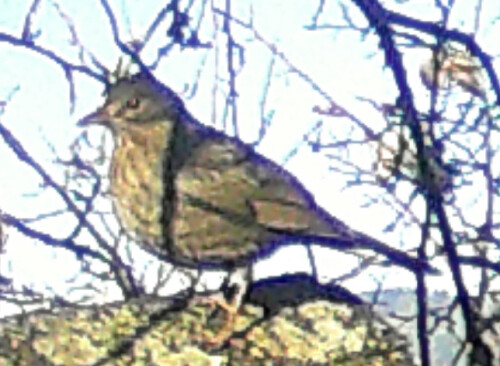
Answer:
[{"xmin": 188, "ymin": 140, "xmax": 336, "ymax": 234}]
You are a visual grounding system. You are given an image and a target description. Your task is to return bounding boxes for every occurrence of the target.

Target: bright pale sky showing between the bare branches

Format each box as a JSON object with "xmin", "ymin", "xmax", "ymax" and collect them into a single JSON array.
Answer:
[{"xmin": 0, "ymin": 0, "xmax": 498, "ymax": 326}]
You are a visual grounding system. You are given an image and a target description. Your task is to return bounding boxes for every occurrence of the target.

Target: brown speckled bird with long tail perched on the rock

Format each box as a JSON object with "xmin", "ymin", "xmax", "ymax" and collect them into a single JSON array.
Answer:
[{"xmin": 78, "ymin": 70, "xmax": 438, "ymax": 339}]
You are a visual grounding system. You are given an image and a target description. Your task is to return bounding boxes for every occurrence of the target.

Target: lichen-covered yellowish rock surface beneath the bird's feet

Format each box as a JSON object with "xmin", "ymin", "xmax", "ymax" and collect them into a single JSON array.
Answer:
[{"xmin": 0, "ymin": 301, "xmax": 411, "ymax": 366}]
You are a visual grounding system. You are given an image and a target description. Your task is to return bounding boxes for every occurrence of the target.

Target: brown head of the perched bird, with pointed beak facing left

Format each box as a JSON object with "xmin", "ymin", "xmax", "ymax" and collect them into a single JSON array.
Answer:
[{"xmin": 78, "ymin": 73, "xmax": 184, "ymax": 133}]
